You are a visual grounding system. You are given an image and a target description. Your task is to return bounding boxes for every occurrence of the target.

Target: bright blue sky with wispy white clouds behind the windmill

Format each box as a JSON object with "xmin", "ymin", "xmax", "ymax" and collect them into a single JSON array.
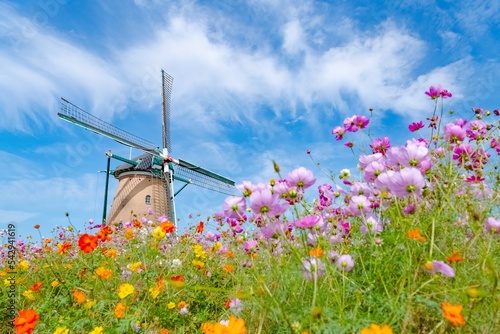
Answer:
[{"xmin": 0, "ymin": 0, "xmax": 500, "ymax": 235}]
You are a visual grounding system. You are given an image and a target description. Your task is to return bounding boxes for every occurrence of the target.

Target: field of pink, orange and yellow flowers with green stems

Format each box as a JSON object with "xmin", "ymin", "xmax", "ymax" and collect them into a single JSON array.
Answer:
[{"xmin": 0, "ymin": 86, "xmax": 500, "ymax": 334}]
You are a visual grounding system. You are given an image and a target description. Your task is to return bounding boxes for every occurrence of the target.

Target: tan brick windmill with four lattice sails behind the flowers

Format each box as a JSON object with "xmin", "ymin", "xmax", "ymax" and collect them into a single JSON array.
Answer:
[{"xmin": 58, "ymin": 70, "xmax": 235, "ymax": 224}]
